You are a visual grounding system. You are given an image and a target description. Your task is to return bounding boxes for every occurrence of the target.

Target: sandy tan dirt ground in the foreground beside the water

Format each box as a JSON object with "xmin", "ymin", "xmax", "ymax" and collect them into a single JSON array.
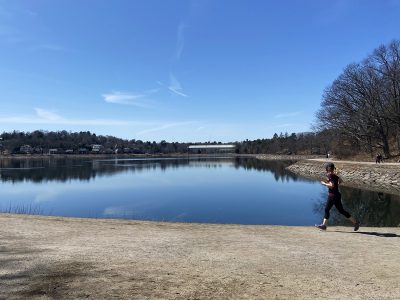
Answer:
[{"xmin": 0, "ymin": 214, "xmax": 400, "ymax": 300}]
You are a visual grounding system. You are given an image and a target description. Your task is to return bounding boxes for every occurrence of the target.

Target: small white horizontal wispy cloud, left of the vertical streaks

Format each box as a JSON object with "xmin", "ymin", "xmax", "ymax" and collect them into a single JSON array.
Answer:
[{"xmin": 102, "ymin": 89, "xmax": 158, "ymax": 108}]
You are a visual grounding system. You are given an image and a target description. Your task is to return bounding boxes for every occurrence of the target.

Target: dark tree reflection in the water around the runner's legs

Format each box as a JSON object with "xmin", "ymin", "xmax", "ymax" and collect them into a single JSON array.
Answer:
[{"xmin": 314, "ymin": 186, "xmax": 400, "ymax": 227}]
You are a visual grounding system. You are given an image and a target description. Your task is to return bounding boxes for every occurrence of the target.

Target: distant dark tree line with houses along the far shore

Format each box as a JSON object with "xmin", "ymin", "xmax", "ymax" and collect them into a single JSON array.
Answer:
[{"xmin": 0, "ymin": 130, "xmax": 329, "ymax": 154}]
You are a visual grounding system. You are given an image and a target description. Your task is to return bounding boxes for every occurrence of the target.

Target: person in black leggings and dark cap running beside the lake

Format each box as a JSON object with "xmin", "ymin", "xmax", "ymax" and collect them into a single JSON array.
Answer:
[{"xmin": 315, "ymin": 163, "xmax": 360, "ymax": 231}]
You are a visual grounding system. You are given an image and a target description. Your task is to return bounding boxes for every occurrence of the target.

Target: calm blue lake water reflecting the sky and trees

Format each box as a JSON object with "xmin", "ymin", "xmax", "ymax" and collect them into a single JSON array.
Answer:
[{"xmin": 0, "ymin": 157, "xmax": 400, "ymax": 226}]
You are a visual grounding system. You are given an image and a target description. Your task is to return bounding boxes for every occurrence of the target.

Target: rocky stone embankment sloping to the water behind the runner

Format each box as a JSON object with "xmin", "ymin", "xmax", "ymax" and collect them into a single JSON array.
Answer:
[{"xmin": 287, "ymin": 159, "xmax": 400, "ymax": 194}]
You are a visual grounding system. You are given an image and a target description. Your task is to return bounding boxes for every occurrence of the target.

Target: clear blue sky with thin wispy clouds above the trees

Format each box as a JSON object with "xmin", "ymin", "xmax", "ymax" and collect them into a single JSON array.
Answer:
[{"xmin": 0, "ymin": 0, "xmax": 400, "ymax": 142}]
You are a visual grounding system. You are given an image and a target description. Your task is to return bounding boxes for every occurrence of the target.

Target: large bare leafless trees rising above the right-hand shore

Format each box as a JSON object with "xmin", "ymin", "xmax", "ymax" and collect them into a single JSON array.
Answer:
[{"xmin": 316, "ymin": 40, "xmax": 400, "ymax": 157}]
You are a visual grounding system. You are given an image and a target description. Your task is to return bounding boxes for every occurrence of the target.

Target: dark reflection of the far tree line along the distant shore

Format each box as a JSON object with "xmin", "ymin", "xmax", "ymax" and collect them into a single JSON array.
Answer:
[{"xmin": 0, "ymin": 157, "xmax": 307, "ymax": 183}]
